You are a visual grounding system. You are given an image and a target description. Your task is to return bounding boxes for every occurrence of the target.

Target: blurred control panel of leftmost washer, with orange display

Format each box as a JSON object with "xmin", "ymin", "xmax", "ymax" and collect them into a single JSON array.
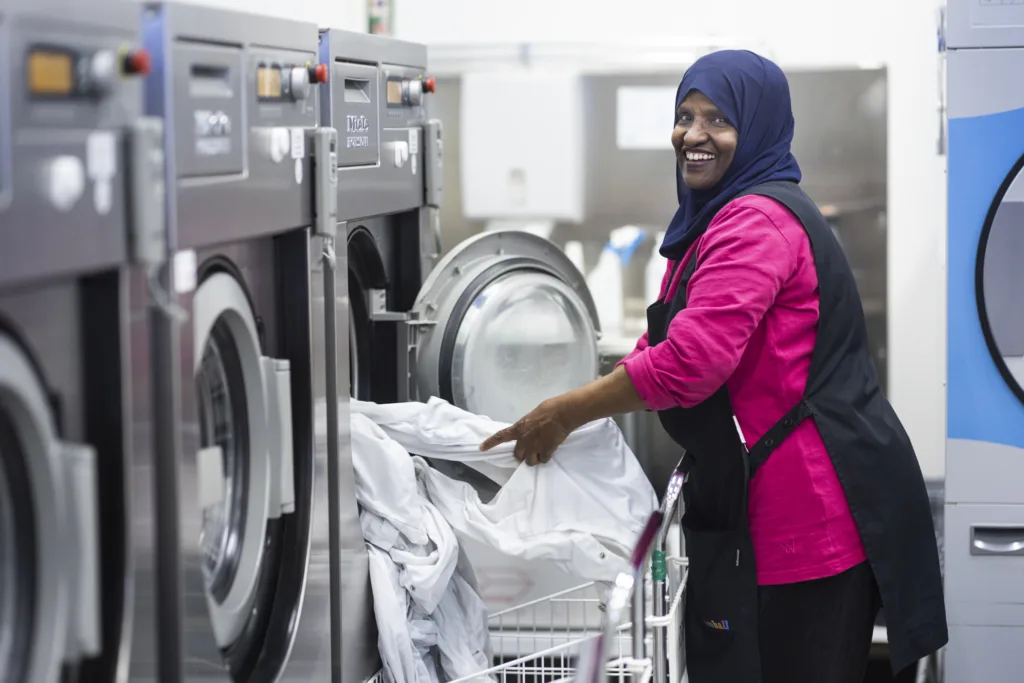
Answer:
[{"xmin": 0, "ymin": 0, "xmax": 151, "ymax": 286}]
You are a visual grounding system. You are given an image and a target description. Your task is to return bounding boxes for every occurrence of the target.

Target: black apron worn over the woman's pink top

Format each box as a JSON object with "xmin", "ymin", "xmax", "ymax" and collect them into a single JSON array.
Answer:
[{"xmin": 647, "ymin": 182, "xmax": 947, "ymax": 683}]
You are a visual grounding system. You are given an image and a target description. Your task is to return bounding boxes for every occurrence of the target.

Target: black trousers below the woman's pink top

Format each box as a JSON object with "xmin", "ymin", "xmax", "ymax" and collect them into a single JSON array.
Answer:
[{"xmin": 758, "ymin": 562, "xmax": 881, "ymax": 683}]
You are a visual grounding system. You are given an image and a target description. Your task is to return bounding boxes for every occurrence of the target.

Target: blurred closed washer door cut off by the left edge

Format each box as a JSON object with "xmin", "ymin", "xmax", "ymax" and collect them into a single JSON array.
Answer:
[{"xmin": 0, "ymin": 333, "xmax": 101, "ymax": 683}]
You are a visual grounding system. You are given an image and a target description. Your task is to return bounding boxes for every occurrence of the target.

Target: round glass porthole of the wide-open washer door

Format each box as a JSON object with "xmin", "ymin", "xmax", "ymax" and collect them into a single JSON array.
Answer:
[{"xmin": 442, "ymin": 269, "xmax": 598, "ymax": 422}]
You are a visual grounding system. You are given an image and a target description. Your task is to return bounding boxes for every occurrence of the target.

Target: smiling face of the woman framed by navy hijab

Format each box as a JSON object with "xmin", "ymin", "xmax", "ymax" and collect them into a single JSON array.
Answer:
[{"xmin": 672, "ymin": 90, "xmax": 739, "ymax": 189}]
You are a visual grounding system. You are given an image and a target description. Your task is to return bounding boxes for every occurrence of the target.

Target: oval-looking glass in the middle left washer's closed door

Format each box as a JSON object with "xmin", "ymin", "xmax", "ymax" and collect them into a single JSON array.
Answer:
[{"xmin": 196, "ymin": 318, "xmax": 249, "ymax": 602}]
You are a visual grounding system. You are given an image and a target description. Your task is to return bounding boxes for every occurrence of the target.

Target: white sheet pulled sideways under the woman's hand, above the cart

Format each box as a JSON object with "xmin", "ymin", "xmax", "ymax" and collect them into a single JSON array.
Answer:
[{"xmin": 352, "ymin": 398, "xmax": 657, "ymax": 582}]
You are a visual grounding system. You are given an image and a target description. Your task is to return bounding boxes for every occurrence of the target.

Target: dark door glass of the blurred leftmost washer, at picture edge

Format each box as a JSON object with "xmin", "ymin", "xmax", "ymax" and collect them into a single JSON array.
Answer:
[{"xmin": 0, "ymin": 409, "xmax": 36, "ymax": 682}]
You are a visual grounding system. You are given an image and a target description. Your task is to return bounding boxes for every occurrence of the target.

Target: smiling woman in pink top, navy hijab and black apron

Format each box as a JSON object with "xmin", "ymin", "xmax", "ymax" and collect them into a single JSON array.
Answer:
[{"xmin": 483, "ymin": 50, "xmax": 946, "ymax": 683}]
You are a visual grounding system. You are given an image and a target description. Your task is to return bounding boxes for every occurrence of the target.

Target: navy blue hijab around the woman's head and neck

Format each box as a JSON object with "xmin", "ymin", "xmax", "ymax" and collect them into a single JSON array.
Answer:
[{"xmin": 660, "ymin": 50, "xmax": 801, "ymax": 260}]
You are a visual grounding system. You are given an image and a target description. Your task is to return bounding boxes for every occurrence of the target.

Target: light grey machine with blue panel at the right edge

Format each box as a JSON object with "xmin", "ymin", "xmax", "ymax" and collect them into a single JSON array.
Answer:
[{"xmin": 940, "ymin": 0, "xmax": 1024, "ymax": 683}]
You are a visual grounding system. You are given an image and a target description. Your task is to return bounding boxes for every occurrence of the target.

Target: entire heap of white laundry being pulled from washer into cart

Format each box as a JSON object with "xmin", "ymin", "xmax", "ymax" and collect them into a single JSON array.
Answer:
[{"xmin": 351, "ymin": 399, "xmax": 656, "ymax": 683}]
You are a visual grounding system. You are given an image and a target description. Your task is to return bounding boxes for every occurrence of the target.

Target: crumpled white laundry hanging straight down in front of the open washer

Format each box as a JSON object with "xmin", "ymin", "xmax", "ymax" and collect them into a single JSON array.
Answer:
[{"xmin": 352, "ymin": 416, "xmax": 490, "ymax": 683}]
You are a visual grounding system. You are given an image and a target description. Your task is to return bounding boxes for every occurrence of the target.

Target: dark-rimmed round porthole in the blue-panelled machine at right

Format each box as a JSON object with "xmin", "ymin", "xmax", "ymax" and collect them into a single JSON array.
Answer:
[{"xmin": 976, "ymin": 158, "xmax": 1024, "ymax": 401}]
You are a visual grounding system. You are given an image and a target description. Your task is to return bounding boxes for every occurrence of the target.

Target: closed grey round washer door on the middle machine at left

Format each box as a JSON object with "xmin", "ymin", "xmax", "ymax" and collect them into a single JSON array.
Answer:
[{"xmin": 192, "ymin": 271, "xmax": 295, "ymax": 663}]
